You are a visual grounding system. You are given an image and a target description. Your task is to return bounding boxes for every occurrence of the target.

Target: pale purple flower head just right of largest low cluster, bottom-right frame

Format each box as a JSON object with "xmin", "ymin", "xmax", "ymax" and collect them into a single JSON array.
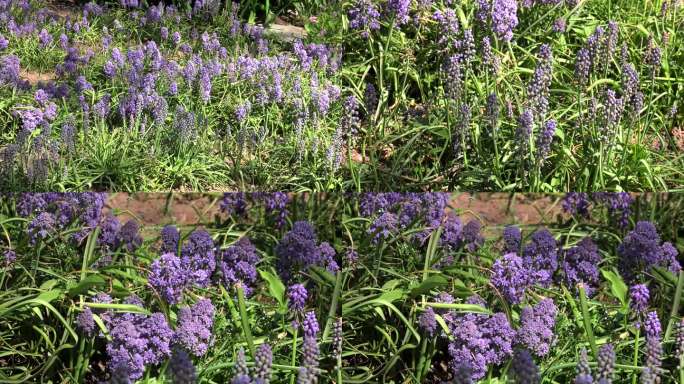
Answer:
[{"xmin": 516, "ymin": 299, "xmax": 558, "ymax": 357}]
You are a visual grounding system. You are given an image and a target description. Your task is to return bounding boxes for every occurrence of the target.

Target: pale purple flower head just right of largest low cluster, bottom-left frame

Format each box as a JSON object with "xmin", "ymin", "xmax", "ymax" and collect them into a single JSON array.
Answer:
[{"xmin": 173, "ymin": 299, "xmax": 214, "ymax": 357}]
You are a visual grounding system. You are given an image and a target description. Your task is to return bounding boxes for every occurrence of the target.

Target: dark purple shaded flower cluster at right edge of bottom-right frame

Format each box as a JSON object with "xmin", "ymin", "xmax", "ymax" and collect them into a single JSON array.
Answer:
[{"xmin": 617, "ymin": 221, "xmax": 681, "ymax": 281}]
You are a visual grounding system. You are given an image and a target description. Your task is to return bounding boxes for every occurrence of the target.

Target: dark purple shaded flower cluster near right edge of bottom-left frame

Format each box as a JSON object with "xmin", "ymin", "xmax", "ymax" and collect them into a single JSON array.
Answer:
[{"xmin": 275, "ymin": 221, "xmax": 339, "ymax": 280}]
